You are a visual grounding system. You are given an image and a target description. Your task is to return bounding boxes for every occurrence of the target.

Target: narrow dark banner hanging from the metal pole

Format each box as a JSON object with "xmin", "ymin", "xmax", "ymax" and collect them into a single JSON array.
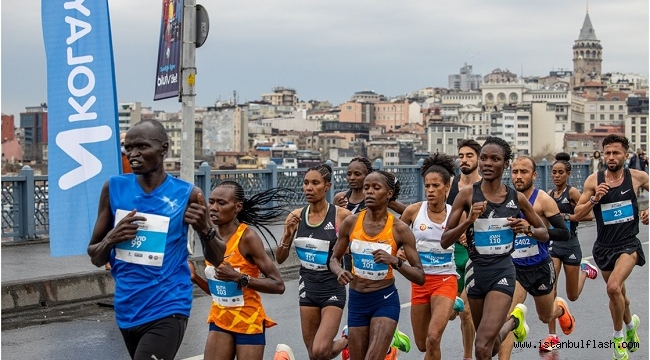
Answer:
[{"xmin": 153, "ymin": 0, "xmax": 183, "ymax": 100}]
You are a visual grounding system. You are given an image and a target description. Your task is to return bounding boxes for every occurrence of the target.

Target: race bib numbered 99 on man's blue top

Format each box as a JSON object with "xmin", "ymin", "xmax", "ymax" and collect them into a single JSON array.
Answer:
[{"xmin": 115, "ymin": 210, "xmax": 169, "ymax": 267}]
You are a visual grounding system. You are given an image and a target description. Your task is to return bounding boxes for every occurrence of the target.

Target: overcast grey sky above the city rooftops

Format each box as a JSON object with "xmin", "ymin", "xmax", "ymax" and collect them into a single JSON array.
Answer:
[{"xmin": 1, "ymin": 0, "xmax": 648, "ymax": 121}]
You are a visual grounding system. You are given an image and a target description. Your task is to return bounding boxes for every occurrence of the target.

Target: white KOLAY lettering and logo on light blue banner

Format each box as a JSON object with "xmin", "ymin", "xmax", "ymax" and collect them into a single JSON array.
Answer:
[{"xmin": 56, "ymin": 0, "xmax": 113, "ymax": 190}]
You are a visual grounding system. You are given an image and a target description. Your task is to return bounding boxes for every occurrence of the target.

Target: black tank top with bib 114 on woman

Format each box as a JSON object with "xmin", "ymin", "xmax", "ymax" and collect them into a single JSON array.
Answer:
[{"xmin": 294, "ymin": 204, "xmax": 338, "ymax": 282}]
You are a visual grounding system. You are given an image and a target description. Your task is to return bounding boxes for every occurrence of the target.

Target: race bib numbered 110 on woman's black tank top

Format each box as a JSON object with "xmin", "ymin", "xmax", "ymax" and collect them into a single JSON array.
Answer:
[{"xmin": 474, "ymin": 218, "xmax": 515, "ymax": 255}]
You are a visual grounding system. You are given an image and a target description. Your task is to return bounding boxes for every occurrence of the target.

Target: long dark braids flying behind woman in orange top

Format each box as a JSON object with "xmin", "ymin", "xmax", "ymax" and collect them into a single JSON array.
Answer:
[{"xmin": 217, "ymin": 180, "xmax": 292, "ymax": 258}]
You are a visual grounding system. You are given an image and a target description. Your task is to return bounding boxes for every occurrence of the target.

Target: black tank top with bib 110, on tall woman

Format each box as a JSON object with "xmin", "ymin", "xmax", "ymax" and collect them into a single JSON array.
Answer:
[{"xmin": 466, "ymin": 180, "xmax": 520, "ymax": 265}]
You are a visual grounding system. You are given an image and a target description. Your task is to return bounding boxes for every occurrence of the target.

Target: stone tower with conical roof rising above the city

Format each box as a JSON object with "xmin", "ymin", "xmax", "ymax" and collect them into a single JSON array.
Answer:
[{"xmin": 573, "ymin": 8, "xmax": 603, "ymax": 87}]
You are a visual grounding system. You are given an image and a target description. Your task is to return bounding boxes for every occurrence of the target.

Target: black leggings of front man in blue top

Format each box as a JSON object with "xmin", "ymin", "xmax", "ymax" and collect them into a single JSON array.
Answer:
[{"xmin": 120, "ymin": 315, "xmax": 187, "ymax": 360}]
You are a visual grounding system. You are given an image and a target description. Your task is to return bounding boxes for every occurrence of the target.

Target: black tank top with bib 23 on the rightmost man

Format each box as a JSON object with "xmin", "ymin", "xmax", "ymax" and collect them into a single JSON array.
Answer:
[{"xmin": 594, "ymin": 169, "xmax": 639, "ymax": 246}]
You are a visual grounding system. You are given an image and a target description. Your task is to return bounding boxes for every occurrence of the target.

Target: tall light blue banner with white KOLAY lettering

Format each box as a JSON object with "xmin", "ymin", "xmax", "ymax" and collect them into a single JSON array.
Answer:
[{"xmin": 41, "ymin": 0, "xmax": 121, "ymax": 256}]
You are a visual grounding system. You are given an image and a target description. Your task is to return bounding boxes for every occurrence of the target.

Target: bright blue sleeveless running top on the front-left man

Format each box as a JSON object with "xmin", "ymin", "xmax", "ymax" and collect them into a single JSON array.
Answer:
[{"xmin": 108, "ymin": 174, "xmax": 194, "ymax": 329}]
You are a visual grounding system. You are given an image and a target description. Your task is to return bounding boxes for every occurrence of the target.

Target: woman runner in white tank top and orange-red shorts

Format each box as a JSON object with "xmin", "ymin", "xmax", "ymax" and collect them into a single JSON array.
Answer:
[{"xmin": 399, "ymin": 154, "xmax": 464, "ymax": 360}]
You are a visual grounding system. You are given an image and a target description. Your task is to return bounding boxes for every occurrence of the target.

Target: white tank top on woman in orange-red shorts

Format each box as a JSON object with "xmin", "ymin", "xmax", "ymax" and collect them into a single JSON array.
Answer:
[{"xmin": 411, "ymin": 201, "xmax": 458, "ymax": 277}]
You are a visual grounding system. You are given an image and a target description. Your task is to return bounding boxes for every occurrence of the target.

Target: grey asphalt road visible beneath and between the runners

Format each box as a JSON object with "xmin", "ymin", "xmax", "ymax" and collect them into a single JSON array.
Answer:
[{"xmin": 1, "ymin": 226, "xmax": 650, "ymax": 360}]
